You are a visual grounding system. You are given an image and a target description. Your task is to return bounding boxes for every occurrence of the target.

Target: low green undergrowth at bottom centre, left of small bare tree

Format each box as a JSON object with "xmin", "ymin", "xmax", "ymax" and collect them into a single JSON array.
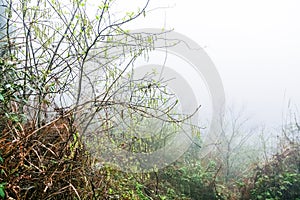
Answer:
[{"xmin": 152, "ymin": 146, "xmax": 224, "ymax": 200}]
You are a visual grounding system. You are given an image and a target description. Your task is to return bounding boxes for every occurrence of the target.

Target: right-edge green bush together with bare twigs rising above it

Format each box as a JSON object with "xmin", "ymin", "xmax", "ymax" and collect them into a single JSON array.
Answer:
[{"xmin": 241, "ymin": 120, "xmax": 300, "ymax": 200}]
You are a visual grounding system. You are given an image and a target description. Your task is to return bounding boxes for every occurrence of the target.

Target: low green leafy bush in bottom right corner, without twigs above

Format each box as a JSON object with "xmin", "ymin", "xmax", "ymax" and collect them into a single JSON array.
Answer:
[{"xmin": 251, "ymin": 147, "xmax": 300, "ymax": 200}]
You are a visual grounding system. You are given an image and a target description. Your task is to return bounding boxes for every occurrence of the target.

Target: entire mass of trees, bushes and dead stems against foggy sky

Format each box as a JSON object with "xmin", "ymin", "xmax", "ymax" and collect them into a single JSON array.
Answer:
[{"xmin": 0, "ymin": 0, "xmax": 300, "ymax": 200}]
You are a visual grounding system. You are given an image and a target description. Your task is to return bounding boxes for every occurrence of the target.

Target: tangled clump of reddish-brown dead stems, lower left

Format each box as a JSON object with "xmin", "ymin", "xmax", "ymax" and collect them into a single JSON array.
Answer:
[{"xmin": 0, "ymin": 117, "xmax": 101, "ymax": 199}]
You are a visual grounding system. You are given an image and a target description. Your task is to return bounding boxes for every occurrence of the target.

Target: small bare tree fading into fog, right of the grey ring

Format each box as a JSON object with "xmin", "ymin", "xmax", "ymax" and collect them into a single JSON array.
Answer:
[{"xmin": 217, "ymin": 106, "xmax": 257, "ymax": 183}]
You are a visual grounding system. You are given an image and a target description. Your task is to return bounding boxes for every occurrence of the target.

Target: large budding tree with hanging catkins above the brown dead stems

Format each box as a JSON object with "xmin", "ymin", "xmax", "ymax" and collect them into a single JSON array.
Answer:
[{"xmin": 1, "ymin": 0, "xmax": 197, "ymax": 172}]
